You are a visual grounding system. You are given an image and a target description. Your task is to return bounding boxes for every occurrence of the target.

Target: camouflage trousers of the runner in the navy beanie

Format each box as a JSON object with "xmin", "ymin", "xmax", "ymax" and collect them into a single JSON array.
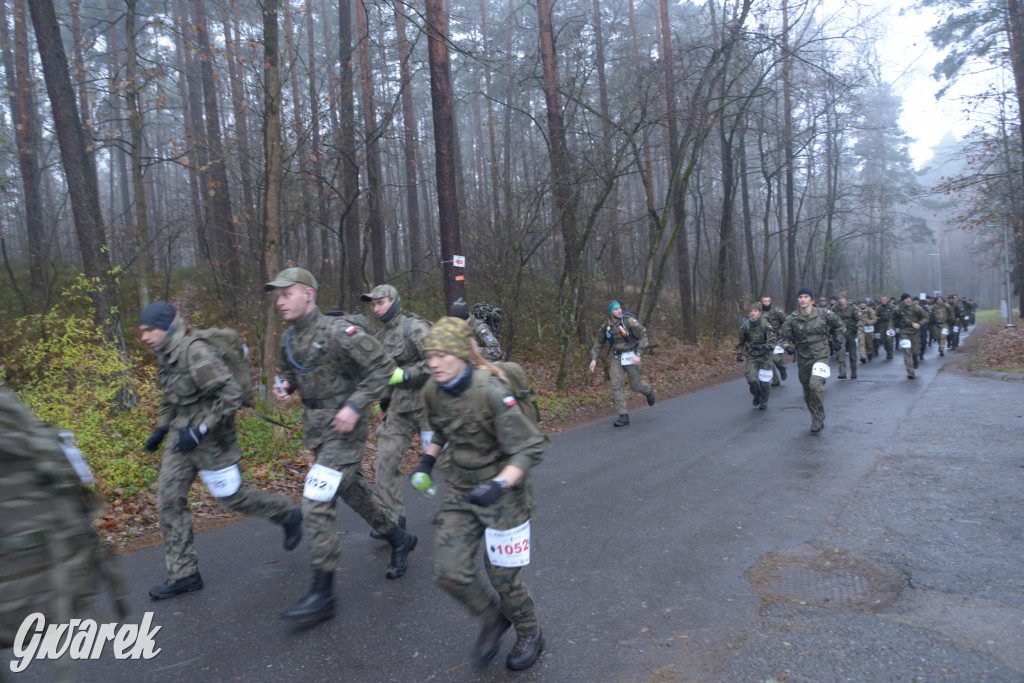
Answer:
[{"xmin": 157, "ymin": 431, "xmax": 295, "ymax": 581}]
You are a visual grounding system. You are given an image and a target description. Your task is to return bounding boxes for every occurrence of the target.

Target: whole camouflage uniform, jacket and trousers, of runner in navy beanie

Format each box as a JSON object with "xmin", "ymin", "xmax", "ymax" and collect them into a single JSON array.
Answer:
[{"xmin": 157, "ymin": 315, "xmax": 294, "ymax": 581}]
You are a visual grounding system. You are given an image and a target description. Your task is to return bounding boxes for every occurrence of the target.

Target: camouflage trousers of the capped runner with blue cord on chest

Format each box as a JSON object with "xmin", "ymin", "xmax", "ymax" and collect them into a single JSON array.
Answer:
[{"xmin": 302, "ymin": 428, "xmax": 396, "ymax": 571}]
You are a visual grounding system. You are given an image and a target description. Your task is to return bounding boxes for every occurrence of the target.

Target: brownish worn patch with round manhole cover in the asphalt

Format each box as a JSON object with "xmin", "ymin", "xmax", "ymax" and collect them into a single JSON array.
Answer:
[{"xmin": 746, "ymin": 546, "xmax": 906, "ymax": 611}]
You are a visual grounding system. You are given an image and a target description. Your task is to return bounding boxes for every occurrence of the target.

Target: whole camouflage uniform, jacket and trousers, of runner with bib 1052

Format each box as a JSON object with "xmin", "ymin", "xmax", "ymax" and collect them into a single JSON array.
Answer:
[{"xmin": 428, "ymin": 370, "xmax": 547, "ymax": 636}]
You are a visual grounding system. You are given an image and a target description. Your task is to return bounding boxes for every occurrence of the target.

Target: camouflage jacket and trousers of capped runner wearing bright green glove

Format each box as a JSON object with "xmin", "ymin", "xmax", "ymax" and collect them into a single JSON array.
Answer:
[{"xmin": 374, "ymin": 312, "xmax": 430, "ymax": 522}]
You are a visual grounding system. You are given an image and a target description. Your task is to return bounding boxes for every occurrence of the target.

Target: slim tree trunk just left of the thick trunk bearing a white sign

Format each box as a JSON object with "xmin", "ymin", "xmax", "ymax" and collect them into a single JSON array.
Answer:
[{"xmin": 394, "ymin": 5, "xmax": 426, "ymax": 289}]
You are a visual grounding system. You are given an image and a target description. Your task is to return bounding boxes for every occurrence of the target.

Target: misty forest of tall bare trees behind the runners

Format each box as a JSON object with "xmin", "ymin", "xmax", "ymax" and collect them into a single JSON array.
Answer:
[{"xmin": 0, "ymin": 0, "xmax": 1024, "ymax": 400}]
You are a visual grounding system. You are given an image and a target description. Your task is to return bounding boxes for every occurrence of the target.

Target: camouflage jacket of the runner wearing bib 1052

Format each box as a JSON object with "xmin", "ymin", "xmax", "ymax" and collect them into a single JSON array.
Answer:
[{"xmin": 427, "ymin": 370, "xmax": 548, "ymax": 490}]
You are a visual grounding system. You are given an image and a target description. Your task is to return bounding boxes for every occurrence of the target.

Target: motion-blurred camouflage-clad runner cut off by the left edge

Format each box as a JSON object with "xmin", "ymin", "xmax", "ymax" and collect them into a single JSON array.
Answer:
[{"xmin": 0, "ymin": 388, "xmax": 127, "ymax": 649}]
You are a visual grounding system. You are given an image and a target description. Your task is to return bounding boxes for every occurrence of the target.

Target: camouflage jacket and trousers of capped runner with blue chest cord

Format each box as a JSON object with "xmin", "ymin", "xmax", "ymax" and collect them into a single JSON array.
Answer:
[{"xmin": 279, "ymin": 307, "xmax": 396, "ymax": 572}]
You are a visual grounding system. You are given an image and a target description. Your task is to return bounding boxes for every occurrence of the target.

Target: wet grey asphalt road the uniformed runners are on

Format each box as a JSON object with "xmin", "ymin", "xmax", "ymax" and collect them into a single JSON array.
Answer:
[{"xmin": 0, "ymin": 327, "xmax": 1024, "ymax": 682}]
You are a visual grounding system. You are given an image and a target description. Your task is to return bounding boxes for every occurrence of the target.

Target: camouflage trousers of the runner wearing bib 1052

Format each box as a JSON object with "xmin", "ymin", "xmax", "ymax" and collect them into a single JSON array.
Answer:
[{"xmin": 434, "ymin": 479, "xmax": 540, "ymax": 636}]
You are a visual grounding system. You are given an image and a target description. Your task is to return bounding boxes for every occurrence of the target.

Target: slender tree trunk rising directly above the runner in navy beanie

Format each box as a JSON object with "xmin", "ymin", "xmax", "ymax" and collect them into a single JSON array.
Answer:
[{"xmin": 125, "ymin": 0, "xmax": 153, "ymax": 310}]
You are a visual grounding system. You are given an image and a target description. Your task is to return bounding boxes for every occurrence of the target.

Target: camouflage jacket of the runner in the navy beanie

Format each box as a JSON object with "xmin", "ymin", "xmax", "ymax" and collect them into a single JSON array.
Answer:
[{"xmin": 157, "ymin": 315, "xmax": 243, "ymax": 433}]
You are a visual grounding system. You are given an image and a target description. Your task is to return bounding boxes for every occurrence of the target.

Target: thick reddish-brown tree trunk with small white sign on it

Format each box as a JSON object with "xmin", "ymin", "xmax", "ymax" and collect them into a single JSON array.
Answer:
[{"xmin": 426, "ymin": 0, "xmax": 465, "ymax": 309}]
